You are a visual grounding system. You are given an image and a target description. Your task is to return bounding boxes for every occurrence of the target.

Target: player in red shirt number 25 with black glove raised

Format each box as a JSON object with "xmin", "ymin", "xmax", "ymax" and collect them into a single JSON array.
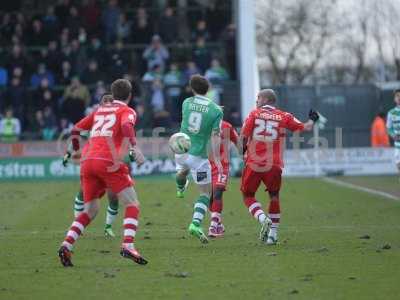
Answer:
[{"xmin": 240, "ymin": 89, "xmax": 319, "ymax": 245}]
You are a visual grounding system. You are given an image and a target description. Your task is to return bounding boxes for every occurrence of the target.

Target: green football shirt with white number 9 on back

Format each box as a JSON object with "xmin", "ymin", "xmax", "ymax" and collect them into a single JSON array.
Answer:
[{"xmin": 181, "ymin": 95, "xmax": 223, "ymax": 158}]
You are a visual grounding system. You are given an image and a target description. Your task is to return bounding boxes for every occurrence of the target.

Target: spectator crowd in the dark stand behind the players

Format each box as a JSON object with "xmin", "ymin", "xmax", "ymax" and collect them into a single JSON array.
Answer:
[{"xmin": 0, "ymin": 0, "xmax": 236, "ymax": 142}]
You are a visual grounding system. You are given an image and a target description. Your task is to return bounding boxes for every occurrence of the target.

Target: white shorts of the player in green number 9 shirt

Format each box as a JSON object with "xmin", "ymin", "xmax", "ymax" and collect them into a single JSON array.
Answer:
[{"xmin": 175, "ymin": 153, "xmax": 211, "ymax": 185}]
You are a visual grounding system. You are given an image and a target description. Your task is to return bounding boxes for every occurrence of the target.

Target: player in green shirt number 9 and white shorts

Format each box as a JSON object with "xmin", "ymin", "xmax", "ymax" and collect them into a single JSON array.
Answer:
[{"xmin": 175, "ymin": 75, "xmax": 223, "ymax": 243}]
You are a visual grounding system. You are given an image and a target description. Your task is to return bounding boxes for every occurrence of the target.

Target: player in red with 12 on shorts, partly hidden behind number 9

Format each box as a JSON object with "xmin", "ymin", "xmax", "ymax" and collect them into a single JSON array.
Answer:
[{"xmin": 208, "ymin": 121, "xmax": 239, "ymax": 238}]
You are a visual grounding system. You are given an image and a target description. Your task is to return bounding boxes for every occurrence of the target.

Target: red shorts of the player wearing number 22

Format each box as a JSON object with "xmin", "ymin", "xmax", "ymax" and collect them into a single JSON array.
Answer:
[{"xmin": 81, "ymin": 159, "xmax": 133, "ymax": 202}]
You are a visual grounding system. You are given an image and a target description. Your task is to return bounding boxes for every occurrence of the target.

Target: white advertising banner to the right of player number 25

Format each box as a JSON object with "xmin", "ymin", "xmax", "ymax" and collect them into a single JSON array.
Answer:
[{"xmin": 283, "ymin": 148, "xmax": 398, "ymax": 176}]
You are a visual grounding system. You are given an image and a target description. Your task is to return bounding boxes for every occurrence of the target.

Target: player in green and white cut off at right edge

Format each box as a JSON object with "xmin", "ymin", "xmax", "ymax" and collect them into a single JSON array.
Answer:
[{"xmin": 386, "ymin": 90, "xmax": 400, "ymax": 172}]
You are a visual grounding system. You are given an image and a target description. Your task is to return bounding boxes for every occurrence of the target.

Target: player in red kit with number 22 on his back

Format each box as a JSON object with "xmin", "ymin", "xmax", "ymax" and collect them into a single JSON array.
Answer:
[{"xmin": 58, "ymin": 79, "xmax": 147, "ymax": 267}]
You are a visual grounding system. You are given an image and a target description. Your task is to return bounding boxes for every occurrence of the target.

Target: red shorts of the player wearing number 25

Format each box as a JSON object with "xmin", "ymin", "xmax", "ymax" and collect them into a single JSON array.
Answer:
[{"xmin": 240, "ymin": 165, "xmax": 282, "ymax": 195}]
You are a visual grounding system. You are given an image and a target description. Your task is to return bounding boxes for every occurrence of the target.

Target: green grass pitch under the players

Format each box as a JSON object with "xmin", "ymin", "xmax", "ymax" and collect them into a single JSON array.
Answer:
[{"xmin": 0, "ymin": 178, "xmax": 400, "ymax": 300}]
